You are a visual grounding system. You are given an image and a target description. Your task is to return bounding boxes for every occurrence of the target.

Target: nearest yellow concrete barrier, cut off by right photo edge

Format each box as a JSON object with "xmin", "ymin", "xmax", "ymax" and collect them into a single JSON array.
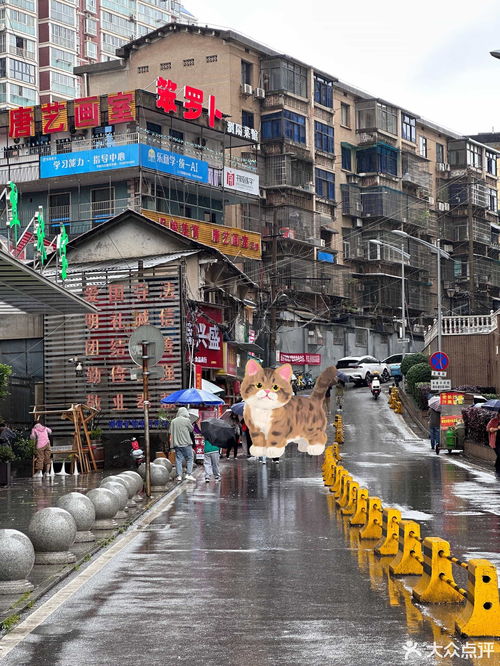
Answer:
[{"xmin": 455, "ymin": 560, "xmax": 500, "ymax": 638}]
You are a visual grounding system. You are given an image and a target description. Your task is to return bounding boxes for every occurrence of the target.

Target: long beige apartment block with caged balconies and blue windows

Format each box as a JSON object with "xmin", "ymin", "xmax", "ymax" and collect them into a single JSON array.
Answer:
[{"xmin": 71, "ymin": 23, "xmax": 500, "ymax": 358}]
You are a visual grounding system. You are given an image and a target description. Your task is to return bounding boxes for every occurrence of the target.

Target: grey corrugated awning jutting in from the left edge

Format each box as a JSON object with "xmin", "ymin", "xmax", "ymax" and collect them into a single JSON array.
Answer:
[{"xmin": 0, "ymin": 250, "xmax": 98, "ymax": 315}]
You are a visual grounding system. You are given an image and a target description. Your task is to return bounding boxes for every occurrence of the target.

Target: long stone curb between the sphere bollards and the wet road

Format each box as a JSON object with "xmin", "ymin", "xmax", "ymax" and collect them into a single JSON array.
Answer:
[{"xmin": 0, "ymin": 470, "xmax": 201, "ymax": 639}]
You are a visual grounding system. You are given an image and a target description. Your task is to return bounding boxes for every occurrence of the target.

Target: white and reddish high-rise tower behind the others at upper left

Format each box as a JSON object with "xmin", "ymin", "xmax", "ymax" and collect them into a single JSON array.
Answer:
[{"xmin": 0, "ymin": 0, "xmax": 195, "ymax": 108}]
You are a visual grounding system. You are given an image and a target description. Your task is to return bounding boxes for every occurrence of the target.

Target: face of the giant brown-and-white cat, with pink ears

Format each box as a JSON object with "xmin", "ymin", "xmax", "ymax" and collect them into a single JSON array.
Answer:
[{"xmin": 241, "ymin": 360, "xmax": 293, "ymax": 410}]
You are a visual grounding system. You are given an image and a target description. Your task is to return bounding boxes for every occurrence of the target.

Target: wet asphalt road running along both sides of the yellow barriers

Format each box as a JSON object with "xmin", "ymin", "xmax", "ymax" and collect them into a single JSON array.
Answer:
[{"xmin": 0, "ymin": 389, "xmax": 500, "ymax": 666}]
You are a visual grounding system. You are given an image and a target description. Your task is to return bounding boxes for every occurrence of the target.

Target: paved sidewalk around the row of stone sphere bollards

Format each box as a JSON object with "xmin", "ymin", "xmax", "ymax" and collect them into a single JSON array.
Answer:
[{"xmin": 0, "ymin": 470, "xmax": 179, "ymax": 633}]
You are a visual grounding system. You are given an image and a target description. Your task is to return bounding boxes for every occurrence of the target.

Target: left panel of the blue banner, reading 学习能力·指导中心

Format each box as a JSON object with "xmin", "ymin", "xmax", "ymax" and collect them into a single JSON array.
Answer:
[{"xmin": 40, "ymin": 144, "xmax": 139, "ymax": 178}]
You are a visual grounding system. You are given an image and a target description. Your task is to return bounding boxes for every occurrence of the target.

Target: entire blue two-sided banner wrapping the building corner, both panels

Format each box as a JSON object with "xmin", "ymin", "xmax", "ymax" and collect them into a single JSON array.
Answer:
[{"xmin": 40, "ymin": 143, "xmax": 208, "ymax": 183}]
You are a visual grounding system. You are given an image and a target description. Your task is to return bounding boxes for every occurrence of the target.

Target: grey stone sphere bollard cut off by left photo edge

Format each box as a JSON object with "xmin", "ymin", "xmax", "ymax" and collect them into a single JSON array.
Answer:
[{"xmin": 0, "ymin": 529, "xmax": 35, "ymax": 594}]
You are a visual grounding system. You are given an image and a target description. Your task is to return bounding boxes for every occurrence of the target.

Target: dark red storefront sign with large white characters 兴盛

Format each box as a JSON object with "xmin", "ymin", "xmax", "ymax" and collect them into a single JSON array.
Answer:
[{"xmin": 186, "ymin": 306, "xmax": 224, "ymax": 369}]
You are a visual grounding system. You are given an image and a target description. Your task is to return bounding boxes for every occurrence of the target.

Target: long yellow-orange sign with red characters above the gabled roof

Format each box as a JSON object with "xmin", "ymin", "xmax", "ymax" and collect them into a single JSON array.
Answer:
[{"xmin": 141, "ymin": 210, "xmax": 262, "ymax": 259}]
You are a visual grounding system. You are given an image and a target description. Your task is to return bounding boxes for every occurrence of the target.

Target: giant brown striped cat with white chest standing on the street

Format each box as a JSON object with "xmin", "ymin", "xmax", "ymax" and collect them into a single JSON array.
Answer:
[{"xmin": 241, "ymin": 359, "xmax": 337, "ymax": 458}]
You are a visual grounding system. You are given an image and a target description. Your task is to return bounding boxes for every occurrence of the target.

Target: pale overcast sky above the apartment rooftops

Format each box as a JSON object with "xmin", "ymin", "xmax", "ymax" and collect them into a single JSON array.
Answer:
[{"xmin": 183, "ymin": 0, "xmax": 500, "ymax": 134}]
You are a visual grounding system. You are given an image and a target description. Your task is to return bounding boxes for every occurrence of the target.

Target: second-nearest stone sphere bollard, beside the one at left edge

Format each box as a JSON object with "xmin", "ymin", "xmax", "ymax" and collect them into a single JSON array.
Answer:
[{"xmin": 28, "ymin": 506, "xmax": 76, "ymax": 564}]
